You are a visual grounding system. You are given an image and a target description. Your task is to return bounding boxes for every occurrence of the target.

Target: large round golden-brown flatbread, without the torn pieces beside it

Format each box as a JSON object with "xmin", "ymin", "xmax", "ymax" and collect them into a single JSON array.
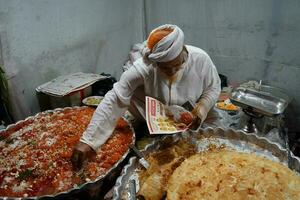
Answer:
[{"xmin": 167, "ymin": 150, "xmax": 300, "ymax": 200}]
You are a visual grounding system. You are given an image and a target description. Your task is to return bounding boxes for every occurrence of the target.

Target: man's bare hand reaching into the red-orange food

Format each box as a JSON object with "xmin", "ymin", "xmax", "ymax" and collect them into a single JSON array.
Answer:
[{"xmin": 71, "ymin": 142, "xmax": 96, "ymax": 170}]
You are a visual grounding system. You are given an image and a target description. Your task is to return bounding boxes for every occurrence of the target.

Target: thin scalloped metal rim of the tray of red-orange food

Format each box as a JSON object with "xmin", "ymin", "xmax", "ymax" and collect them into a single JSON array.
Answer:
[{"xmin": 0, "ymin": 106, "xmax": 135, "ymax": 200}]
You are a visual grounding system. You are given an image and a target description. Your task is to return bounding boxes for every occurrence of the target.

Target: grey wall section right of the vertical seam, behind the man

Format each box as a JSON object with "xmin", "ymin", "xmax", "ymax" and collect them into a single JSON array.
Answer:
[{"xmin": 146, "ymin": 0, "xmax": 300, "ymax": 131}]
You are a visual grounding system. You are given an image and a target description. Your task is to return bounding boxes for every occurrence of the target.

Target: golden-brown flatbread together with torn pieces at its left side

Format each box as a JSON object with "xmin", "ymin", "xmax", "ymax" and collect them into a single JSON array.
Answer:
[{"xmin": 138, "ymin": 147, "xmax": 300, "ymax": 200}]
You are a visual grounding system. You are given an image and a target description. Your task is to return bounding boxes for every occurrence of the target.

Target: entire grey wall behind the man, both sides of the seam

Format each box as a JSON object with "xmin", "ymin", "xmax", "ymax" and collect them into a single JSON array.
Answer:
[{"xmin": 0, "ymin": 0, "xmax": 300, "ymax": 131}]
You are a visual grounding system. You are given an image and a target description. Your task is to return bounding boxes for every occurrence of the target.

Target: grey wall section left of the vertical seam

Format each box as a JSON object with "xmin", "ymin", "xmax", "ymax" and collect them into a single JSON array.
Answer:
[{"xmin": 0, "ymin": 0, "xmax": 143, "ymax": 120}]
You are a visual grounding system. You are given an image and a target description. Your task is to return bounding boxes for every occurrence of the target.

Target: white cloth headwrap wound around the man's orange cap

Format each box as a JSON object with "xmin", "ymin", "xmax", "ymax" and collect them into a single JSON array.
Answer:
[{"xmin": 143, "ymin": 24, "xmax": 184, "ymax": 62}]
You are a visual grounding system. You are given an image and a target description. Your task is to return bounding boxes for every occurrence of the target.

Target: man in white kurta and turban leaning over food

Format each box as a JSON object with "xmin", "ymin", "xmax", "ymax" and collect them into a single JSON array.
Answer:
[{"xmin": 72, "ymin": 24, "xmax": 220, "ymax": 168}]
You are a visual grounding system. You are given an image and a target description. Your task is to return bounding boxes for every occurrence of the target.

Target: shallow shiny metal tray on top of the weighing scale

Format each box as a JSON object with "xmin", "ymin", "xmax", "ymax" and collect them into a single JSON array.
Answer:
[{"xmin": 230, "ymin": 88, "xmax": 289, "ymax": 116}]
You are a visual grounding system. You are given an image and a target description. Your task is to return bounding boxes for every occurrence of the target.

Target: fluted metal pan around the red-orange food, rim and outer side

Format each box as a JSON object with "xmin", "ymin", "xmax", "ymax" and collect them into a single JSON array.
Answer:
[{"xmin": 0, "ymin": 106, "xmax": 135, "ymax": 200}]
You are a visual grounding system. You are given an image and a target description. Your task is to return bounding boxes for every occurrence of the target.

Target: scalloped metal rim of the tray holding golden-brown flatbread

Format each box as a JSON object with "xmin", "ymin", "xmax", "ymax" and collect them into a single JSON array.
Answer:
[{"xmin": 113, "ymin": 127, "xmax": 300, "ymax": 200}]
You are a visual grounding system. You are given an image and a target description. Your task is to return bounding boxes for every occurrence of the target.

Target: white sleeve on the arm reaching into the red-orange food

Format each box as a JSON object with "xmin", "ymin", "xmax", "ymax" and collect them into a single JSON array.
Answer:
[{"xmin": 80, "ymin": 66, "xmax": 143, "ymax": 150}]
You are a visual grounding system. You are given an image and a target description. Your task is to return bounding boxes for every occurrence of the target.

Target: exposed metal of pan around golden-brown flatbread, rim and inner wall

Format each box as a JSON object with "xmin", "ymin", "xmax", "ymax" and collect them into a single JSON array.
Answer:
[{"xmin": 113, "ymin": 128, "xmax": 300, "ymax": 200}]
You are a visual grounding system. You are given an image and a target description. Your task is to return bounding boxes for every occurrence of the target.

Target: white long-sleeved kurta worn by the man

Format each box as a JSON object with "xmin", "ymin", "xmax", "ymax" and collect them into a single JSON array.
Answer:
[{"xmin": 80, "ymin": 45, "xmax": 221, "ymax": 150}]
